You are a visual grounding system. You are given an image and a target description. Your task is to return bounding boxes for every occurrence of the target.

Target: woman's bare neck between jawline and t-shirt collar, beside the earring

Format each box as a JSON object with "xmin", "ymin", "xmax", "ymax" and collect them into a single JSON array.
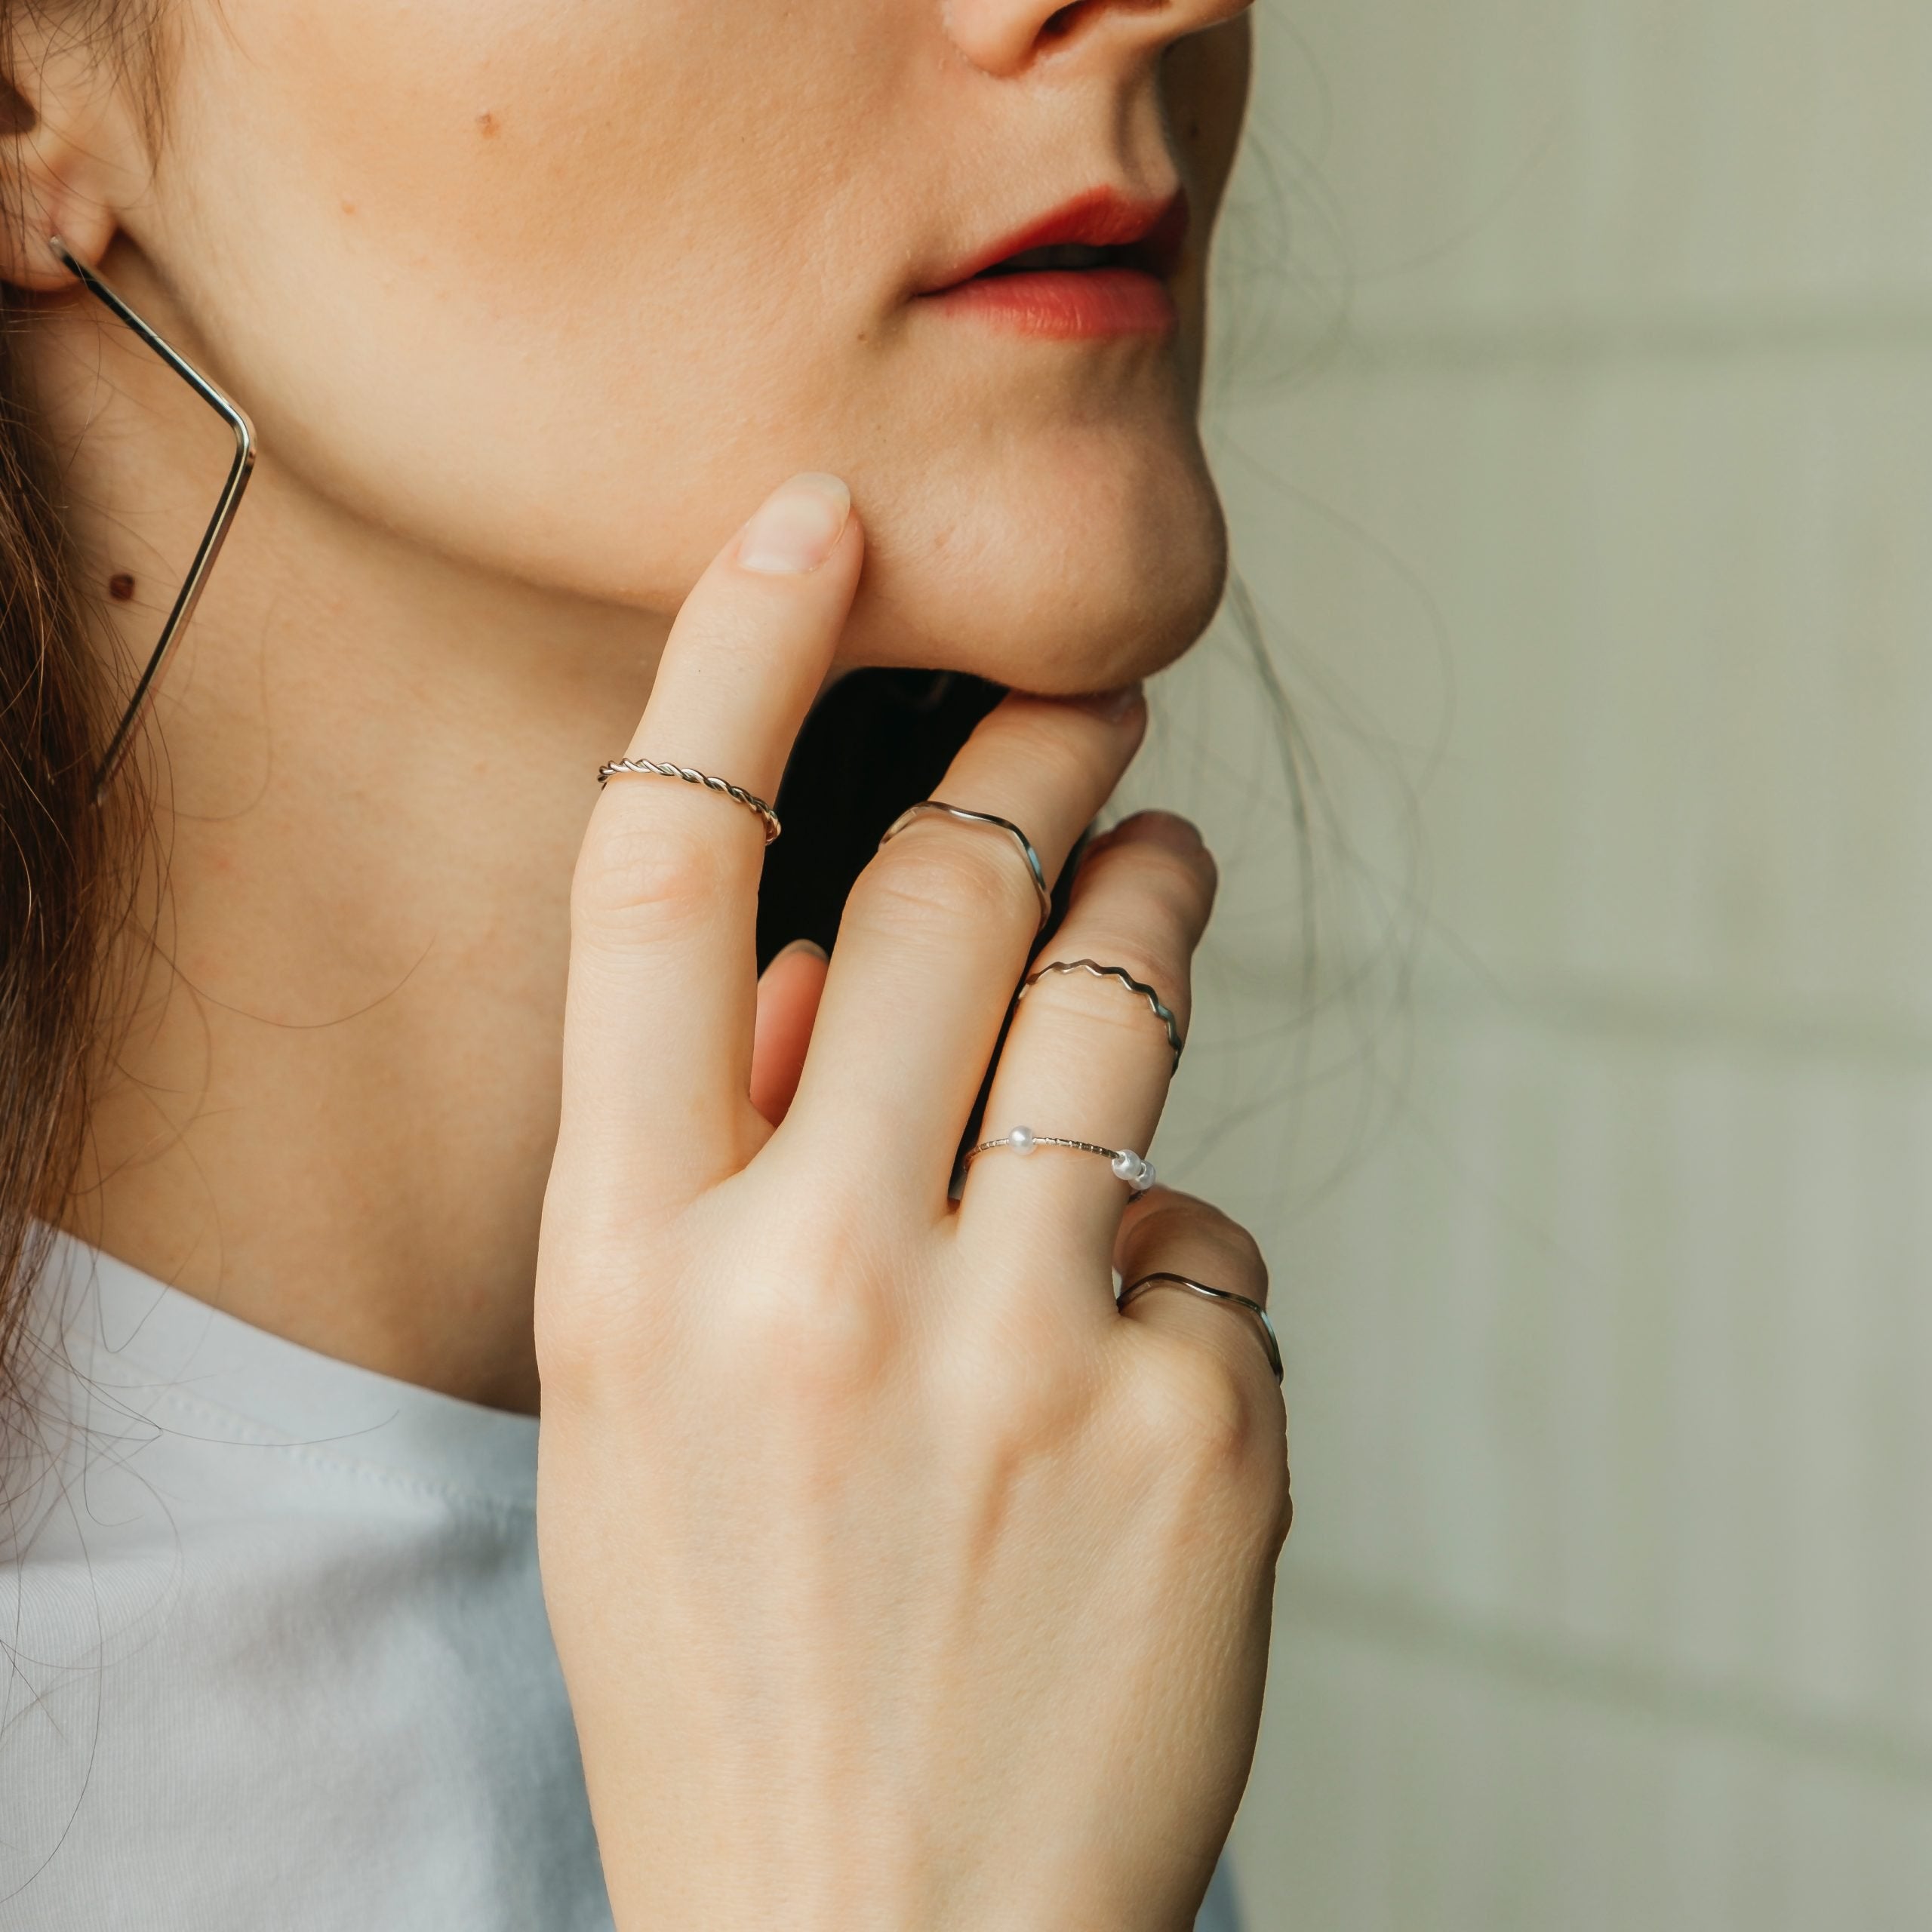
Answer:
[{"xmin": 35, "ymin": 280, "xmax": 665, "ymax": 1408}]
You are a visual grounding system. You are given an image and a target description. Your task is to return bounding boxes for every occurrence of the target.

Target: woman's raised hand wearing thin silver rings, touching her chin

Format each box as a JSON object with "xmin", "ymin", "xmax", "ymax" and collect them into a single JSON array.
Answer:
[{"xmin": 537, "ymin": 479, "xmax": 1289, "ymax": 1932}]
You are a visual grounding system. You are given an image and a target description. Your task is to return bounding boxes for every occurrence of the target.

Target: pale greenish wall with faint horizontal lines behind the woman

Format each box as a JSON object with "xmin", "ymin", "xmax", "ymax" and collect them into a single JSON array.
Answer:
[{"xmin": 1144, "ymin": 0, "xmax": 1932, "ymax": 1932}]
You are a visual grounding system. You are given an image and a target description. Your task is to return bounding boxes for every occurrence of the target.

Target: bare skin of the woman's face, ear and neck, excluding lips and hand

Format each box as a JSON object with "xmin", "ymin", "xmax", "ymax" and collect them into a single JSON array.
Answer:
[{"xmin": 0, "ymin": 0, "xmax": 1246, "ymax": 1408}]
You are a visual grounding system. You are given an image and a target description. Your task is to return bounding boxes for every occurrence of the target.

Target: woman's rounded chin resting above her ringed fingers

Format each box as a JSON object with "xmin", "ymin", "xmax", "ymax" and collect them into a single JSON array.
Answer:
[{"xmin": 841, "ymin": 437, "xmax": 1227, "ymax": 697}]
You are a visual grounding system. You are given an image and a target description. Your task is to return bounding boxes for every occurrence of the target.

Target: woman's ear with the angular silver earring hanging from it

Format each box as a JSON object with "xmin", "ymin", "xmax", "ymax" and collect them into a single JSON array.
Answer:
[{"xmin": 0, "ymin": 20, "xmax": 151, "ymax": 290}]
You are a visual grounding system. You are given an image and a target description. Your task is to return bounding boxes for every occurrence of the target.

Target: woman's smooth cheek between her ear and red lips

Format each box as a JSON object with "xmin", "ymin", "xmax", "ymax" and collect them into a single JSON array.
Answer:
[{"xmin": 162, "ymin": 0, "xmax": 906, "ymax": 587}]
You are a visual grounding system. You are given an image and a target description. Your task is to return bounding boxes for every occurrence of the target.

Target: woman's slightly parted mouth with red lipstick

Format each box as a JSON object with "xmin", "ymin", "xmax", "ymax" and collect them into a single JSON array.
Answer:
[{"xmin": 918, "ymin": 189, "xmax": 1188, "ymax": 342}]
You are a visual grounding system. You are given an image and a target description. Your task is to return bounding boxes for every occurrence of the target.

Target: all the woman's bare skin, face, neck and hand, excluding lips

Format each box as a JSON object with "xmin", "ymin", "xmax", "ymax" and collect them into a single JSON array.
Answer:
[{"xmin": 10, "ymin": 11, "xmax": 1289, "ymax": 1932}]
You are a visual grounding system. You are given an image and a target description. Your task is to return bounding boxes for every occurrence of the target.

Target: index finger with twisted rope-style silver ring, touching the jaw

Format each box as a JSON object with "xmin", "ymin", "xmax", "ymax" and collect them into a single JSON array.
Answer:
[{"xmin": 558, "ymin": 475, "xmax": 863, "ymax": 1204}]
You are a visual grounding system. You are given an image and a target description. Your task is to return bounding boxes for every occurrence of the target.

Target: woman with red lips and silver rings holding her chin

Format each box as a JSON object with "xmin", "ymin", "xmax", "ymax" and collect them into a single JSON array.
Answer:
[{"xmin": 0, "ymin": 0, "xmax": 1289, "ymax": 1932}]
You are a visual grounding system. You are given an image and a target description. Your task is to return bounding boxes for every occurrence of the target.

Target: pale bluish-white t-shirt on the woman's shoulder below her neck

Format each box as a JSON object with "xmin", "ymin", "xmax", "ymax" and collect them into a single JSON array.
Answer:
[{"xmin": 0, "ymin": 1236, "xmax": 1236, "ymax": 1932}]
